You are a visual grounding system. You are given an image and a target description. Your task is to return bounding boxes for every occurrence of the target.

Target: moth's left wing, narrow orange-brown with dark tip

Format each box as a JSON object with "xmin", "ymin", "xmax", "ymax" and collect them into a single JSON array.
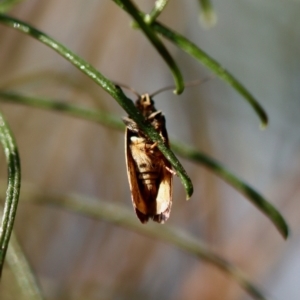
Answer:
[{"xmin": 125, "ymin": 128, "xmax": 149, "ymax": 223}]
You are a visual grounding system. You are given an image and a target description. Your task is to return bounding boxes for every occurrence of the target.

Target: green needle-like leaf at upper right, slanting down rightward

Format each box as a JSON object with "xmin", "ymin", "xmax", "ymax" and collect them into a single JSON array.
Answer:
[{"xmin": 151, "ymin": 22, "xmax": 268, "ymax": 128}]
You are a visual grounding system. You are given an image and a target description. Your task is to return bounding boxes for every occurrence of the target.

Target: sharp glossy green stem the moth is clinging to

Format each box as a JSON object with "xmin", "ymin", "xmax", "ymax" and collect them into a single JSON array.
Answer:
[{"xmin": 0, "ymin": 12, "xmax": 193, "ymax": 199}]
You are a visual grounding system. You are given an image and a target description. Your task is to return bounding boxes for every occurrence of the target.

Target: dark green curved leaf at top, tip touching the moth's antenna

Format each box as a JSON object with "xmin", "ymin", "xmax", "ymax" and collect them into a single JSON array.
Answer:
[{"xmin": 113, "ymin": 0, "xmax": 184, "ymax": 94}]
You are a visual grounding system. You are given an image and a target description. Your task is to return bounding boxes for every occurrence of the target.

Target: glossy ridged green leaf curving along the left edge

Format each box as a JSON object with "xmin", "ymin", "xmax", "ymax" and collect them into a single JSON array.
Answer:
[{"xmin": 0, "ymin": 109, "xmax": 21, "ymax": 276}]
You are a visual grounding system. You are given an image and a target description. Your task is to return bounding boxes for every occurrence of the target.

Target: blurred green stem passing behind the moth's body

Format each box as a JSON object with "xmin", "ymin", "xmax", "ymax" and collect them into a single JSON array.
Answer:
[{"xmin": 0, "ymin": 90, "xmax": 288, "ymax": 238}]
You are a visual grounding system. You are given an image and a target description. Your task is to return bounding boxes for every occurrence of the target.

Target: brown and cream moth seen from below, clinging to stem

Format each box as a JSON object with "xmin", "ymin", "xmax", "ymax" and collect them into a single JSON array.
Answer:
[{"xmin": 122, "ymin": 89, "xmax": 175, "ymax": 223}]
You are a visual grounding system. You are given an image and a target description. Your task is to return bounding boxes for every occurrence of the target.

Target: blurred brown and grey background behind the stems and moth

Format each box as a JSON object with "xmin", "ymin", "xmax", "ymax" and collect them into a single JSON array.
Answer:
[{"xmin": 0, "ymin": 0, "xmax": 300, "ymax": 300}]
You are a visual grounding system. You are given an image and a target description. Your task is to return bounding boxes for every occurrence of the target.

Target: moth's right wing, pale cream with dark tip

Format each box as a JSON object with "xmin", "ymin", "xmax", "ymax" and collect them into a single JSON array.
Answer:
[{"xmin": 153, "ymin": 161, "xmax": 173, "ymax": 223}]
